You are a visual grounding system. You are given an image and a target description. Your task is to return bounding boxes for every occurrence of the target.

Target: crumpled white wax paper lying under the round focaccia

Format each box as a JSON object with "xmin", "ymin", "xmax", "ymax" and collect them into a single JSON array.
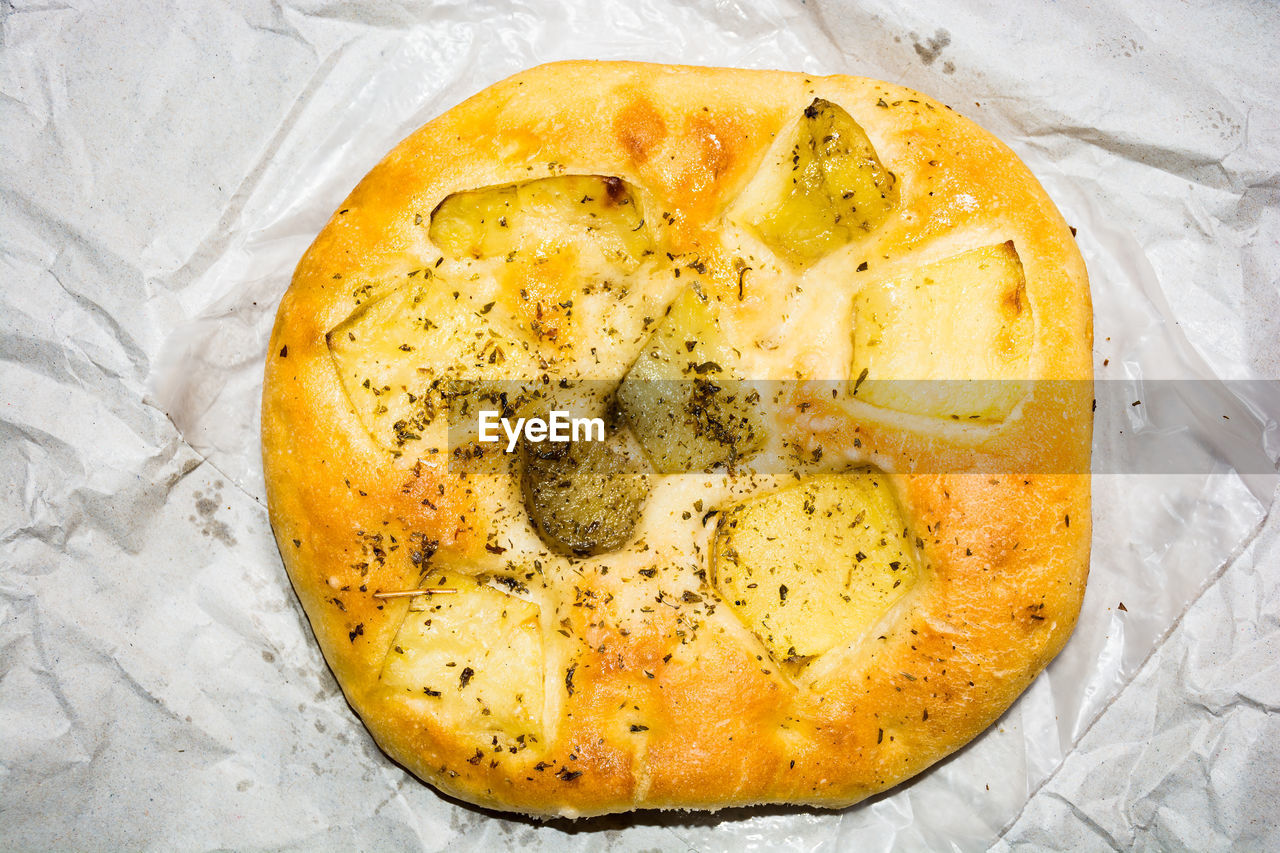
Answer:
[{"xmin": 0, "ymin": 0, "xmax": 1280, "ymax": 850}]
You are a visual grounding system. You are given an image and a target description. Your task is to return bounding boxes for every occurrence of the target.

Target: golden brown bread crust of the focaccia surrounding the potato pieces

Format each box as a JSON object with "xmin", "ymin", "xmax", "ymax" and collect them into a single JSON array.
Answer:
[{"xmin": 262, "ymin": 56, "xmax": 1092, "ymax": 816}]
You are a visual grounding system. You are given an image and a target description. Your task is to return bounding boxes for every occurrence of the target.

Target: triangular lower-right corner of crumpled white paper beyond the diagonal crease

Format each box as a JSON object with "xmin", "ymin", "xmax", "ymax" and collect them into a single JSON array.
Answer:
[{"xmin": 997, "ymin": 504, "xmax": 1280, "ymax": 850}]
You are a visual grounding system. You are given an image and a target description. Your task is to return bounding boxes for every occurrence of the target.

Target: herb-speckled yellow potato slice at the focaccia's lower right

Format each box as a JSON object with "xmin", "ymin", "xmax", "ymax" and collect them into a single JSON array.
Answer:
[{"xmin": 712, "ymin": 469, "xmax": 919, "ymax": 662}]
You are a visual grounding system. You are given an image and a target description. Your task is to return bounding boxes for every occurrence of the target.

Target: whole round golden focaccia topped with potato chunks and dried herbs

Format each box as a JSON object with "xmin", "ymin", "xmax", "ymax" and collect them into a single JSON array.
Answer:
[{"xmin": 262, "ymin": 61, "xmax": 1092, "ymax": 816}]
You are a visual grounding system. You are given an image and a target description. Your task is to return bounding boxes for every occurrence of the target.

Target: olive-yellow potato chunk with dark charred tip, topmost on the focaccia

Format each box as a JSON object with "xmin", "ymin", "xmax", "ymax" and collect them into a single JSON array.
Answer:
[{"xmin": 746, "ymin": 99, "xmax": 897, "ymax": 264}]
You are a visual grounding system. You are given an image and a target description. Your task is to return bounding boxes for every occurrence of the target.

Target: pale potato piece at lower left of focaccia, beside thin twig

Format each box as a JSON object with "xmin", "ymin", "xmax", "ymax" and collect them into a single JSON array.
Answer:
[{"xmin": 381, "ymin": 575, "xmax": 545, "ymax": 742}]
